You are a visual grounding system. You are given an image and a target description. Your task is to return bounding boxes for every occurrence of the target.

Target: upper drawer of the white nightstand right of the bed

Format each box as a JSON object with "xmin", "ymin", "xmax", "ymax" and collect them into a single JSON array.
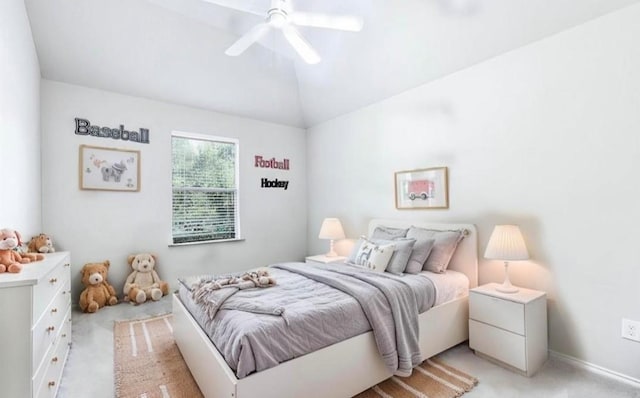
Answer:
[{"xmin": 469, "ymin": 291, "xmax": 525, "ymax": 336}]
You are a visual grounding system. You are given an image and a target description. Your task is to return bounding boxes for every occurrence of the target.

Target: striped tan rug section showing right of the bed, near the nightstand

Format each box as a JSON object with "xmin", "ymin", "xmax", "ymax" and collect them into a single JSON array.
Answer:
[{"xmin": 354, "ymin": 358, "xmax": 478, "ymax": 398}]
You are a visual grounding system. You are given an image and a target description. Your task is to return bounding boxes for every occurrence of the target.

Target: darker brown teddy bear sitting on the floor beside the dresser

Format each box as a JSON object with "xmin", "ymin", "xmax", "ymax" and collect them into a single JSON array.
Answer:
[{"xmin": 80, "ymin": 260, "xmax": 118, "ymax": 313}]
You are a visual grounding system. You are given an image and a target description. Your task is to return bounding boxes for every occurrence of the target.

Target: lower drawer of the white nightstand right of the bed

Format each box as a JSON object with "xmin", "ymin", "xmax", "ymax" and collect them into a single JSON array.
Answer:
[{"xmin": 469, "ymin": 319, "xmax": 527, "ymax": 371}]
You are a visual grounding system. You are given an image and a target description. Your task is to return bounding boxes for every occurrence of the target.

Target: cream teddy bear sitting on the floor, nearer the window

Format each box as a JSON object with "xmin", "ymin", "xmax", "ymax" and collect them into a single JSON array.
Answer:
[{"xmin": 123, "ymin": 253, "xmax": 169, "ymax": 304}]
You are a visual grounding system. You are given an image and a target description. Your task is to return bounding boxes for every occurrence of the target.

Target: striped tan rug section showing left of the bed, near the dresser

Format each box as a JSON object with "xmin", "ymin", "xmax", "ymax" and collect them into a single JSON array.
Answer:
[{"xmin": 113, "ymin": 314, "xmax": 202, "ymax": 398}]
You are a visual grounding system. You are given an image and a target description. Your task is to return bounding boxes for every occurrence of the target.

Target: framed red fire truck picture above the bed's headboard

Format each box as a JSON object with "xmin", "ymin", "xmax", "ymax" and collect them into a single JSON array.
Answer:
[{"xmin": 395, "ymin": 167, "xmax": 449, "ymax": 210}]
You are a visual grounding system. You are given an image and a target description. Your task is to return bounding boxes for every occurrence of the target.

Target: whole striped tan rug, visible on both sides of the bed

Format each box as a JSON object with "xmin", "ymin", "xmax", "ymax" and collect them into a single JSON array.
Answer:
[{"xmin": 113, "ymin": 314, "xmax": 478, "ymax": 398}]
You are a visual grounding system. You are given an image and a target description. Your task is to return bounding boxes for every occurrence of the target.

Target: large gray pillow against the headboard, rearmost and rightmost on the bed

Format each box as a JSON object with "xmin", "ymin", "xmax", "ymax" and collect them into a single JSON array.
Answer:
[{"xmin": 407, "ymin": 227, "xmax": 464, "ymax": 273}]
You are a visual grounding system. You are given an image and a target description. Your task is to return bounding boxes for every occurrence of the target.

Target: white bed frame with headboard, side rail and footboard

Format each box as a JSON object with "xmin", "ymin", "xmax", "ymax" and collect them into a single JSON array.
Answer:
[{"xmin": 173, "ymin": 219, "xmax": 478, "ymax": 398}]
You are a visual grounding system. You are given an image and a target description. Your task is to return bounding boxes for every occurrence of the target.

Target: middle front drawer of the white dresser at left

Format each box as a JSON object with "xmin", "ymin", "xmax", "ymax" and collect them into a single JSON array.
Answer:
[{"xmin": 31, "ymin": 279, "xmax": 71, "ymax": 373}]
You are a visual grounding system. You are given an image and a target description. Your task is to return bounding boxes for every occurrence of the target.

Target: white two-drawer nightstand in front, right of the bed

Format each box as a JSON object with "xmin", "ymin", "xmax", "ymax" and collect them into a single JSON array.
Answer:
[{"xmin": 469, "ymin": 283, "xmax": 547, "ymax": 376}]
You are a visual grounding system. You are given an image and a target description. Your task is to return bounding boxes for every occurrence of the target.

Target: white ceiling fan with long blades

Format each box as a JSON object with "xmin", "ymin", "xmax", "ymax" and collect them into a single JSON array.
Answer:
[{"xmin": 204, "ymin": 0, "xmax": 362, "ymax": 64}]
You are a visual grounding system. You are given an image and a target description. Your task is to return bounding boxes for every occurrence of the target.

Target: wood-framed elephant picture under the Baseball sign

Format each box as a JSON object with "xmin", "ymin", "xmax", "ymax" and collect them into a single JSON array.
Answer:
[{"xmin": 80, "ymin": 145, "xmax": 140, "ymax": 192}]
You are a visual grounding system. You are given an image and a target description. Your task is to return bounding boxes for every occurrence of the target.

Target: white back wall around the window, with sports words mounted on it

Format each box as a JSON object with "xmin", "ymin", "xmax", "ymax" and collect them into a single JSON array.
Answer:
[{"xmin": 42, "ymin": 80, "xmax": 306, "ymax": 304}]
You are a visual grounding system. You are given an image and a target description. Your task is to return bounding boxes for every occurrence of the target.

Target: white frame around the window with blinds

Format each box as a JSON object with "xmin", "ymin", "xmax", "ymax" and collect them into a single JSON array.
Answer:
[{"xmin": 169, "ymin": 131, "xmax": 243, "ymax": 246}]
